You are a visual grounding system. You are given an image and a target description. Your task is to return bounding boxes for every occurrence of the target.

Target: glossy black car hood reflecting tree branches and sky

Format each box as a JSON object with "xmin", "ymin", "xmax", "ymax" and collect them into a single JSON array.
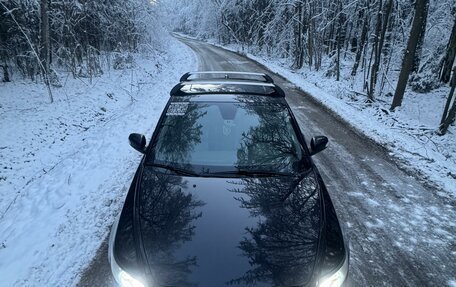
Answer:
[{"xmin": 124, "ymin": 168, "xmax": 322, "ymax": 287}]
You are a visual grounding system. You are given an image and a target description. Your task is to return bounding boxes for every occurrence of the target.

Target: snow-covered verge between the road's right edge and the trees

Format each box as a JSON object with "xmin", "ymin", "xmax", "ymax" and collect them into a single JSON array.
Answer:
[{"xmin": 200, "ymin": 36, "xmax": 456, "ymax": 196}]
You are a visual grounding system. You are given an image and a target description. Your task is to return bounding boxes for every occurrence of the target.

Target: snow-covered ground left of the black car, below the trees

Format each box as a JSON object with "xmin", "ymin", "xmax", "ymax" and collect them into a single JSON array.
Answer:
[{"xmin": 0, "ymin": 39, "xmax": 196, "ymax": 286}]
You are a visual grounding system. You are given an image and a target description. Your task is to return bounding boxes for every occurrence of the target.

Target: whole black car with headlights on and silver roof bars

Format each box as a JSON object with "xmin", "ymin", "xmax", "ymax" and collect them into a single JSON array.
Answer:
[{"xmin": 109, "ymin": 72, "xmax": 349, "ymax": 287}]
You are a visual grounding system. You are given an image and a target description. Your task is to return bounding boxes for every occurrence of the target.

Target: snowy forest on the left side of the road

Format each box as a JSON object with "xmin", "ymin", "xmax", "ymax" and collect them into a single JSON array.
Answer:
[{"xmin": 0, "ymin": 0, "xmax": 162, "ymax": 102}]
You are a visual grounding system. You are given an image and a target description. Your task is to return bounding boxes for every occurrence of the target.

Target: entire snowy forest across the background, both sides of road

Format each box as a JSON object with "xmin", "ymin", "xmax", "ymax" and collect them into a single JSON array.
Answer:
[{"xmin": 0, "ymin": 0, "xmax": 456, "ymax": 134}]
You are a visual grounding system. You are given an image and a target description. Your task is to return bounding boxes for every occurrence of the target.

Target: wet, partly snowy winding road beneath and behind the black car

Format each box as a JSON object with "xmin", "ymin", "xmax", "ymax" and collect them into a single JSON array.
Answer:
[{"xmin": 79, "ymin": 36, "xmax": 456, "ymax": 286}]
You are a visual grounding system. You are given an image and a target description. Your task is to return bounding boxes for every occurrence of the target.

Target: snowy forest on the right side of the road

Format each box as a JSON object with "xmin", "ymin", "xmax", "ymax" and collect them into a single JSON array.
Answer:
[{"xmin": 163, "ymin": 0, "xmax": 456, "ymax": 133}]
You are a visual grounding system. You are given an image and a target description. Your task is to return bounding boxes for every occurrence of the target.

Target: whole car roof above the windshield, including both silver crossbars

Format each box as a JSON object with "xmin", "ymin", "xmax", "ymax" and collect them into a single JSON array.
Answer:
[{"xmin": 170, "ymin": 71, "xmax": 285, "ymax": 98}]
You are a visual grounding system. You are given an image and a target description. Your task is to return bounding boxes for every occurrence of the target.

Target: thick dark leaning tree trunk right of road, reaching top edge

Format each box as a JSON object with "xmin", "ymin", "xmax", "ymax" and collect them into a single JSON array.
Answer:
[{"xmin": 390, "ymin": 0, "xmax": 429, "ymax": 110}]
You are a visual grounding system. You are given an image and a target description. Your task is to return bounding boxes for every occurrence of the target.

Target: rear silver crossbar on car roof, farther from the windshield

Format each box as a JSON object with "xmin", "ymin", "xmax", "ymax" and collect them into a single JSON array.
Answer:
[{"xmin": 180, "ymin": 71, "xmax": 274, "ymax": 84}]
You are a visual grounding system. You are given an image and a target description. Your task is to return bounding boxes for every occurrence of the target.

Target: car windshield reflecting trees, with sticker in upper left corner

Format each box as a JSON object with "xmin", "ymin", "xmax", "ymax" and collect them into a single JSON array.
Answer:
[{"xmin": 146, "ymin": 97, "xmax": 303, "ymax": 174}]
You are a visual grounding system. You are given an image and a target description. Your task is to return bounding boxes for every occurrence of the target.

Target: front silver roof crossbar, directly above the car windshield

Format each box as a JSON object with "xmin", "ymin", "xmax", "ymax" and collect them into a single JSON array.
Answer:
[{"xmin": 170, "ymin": 81, "xmax": 285, "ymax": 98}]
